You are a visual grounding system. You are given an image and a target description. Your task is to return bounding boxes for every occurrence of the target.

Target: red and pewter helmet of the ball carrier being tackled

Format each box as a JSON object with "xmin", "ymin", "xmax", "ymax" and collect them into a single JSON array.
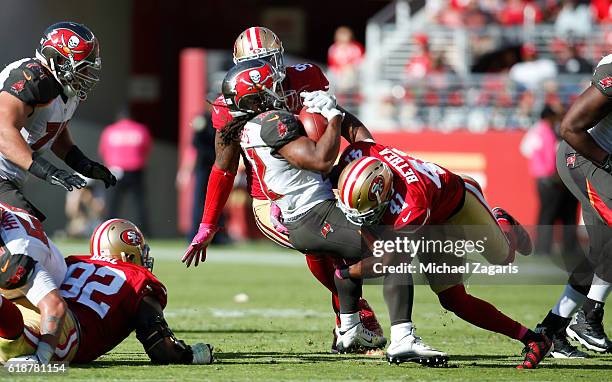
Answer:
[{"xmin": 221, "ymin": 59, "xmax": 286, "ymax": 114}]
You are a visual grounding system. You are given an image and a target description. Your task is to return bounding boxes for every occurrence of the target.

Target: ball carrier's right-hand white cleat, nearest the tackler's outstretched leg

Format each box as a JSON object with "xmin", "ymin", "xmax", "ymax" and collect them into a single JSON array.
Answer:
[{"xmin": 386, "ymin": 328, "xmax": 448, "ymax": 367}]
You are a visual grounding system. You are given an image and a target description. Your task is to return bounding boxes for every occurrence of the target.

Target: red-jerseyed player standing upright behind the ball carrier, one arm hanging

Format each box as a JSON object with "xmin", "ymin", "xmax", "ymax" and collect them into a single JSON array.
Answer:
[{"xmin": 183, "ymin": 27, "xmax": 382, "ymax": 349}]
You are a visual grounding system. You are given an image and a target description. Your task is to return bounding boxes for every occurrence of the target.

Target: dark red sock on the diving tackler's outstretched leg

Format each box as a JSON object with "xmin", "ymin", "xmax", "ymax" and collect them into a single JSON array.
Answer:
[{"xmin": 438, "ymin": 284, "xmax": 526, "ymax": 341}]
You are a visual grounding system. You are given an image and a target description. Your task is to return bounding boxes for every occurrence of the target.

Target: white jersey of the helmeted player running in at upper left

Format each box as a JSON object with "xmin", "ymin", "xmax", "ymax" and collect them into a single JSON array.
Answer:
[{"xmin": 0, "ymin": 58, "xmax": 79, "ymax": 186}]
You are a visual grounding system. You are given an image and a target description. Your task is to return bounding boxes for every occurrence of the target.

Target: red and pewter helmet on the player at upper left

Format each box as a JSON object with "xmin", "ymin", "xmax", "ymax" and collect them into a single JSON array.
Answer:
[{"xmin": 36, "ymin": 22, "xmax": 102, "ymax": 100}]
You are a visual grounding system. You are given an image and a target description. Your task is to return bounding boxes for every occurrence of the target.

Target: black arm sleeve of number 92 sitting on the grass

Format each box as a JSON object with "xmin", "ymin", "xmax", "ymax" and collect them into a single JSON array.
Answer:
[{"xmin": 136, "ymin": 296, "xmax": 193, "ymax": 365}]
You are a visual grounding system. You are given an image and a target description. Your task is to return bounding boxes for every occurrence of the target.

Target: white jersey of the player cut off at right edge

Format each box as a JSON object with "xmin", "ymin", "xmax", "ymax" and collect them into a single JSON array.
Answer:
[{"xmin": 589, "ymin": 54, "xmax": 612, "ymax": 153}]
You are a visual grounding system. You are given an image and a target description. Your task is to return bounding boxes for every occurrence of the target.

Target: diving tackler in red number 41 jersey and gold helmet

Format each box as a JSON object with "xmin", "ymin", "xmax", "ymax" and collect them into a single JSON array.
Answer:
[{"xmin": 338, "ymin": 142, "xmax": 551, "ymax": 368}]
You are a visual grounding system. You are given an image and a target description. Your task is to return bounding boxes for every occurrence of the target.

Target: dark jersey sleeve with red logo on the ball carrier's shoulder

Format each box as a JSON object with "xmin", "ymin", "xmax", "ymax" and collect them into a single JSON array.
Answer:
[{"xmin": 260, "ymin": 111, "xmax": 306, "ymax": 153}]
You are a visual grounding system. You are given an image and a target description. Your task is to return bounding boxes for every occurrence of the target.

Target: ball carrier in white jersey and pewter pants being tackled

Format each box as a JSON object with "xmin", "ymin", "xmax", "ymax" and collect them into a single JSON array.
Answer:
[{"xmin": 191, "ymin": 60, "xmax": 454, "ymax": 364}]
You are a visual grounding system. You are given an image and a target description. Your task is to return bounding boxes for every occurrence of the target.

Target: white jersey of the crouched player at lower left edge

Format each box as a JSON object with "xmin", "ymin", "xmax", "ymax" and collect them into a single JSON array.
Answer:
[{"xmin": 0, "ymin": 203, "xmax": 66, "ymax": 304}]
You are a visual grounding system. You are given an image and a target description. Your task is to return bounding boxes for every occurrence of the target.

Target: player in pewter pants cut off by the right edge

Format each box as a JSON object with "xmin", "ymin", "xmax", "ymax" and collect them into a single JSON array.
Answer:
[{"xmin": 538, "ymin": 55, "xmax": 612, "ymax": 358}]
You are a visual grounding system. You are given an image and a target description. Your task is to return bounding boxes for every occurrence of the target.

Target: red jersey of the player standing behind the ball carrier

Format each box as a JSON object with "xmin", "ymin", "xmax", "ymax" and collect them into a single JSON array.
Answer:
[{"xmin": 212, "ymin": 63, "xmax": 329, "ymax": 200}]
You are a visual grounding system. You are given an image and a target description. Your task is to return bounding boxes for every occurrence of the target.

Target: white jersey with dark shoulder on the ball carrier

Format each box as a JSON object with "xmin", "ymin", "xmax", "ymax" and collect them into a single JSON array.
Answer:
[{"xmin": 240, "ymin": 110, "xmax": 334, "ymax": 220}]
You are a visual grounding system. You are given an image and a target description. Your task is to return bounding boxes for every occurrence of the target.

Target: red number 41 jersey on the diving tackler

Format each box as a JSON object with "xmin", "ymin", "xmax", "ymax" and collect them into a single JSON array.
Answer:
[{"xmin": 338, "ymin": 142, "xmax": 465, "ymax": 230}]
